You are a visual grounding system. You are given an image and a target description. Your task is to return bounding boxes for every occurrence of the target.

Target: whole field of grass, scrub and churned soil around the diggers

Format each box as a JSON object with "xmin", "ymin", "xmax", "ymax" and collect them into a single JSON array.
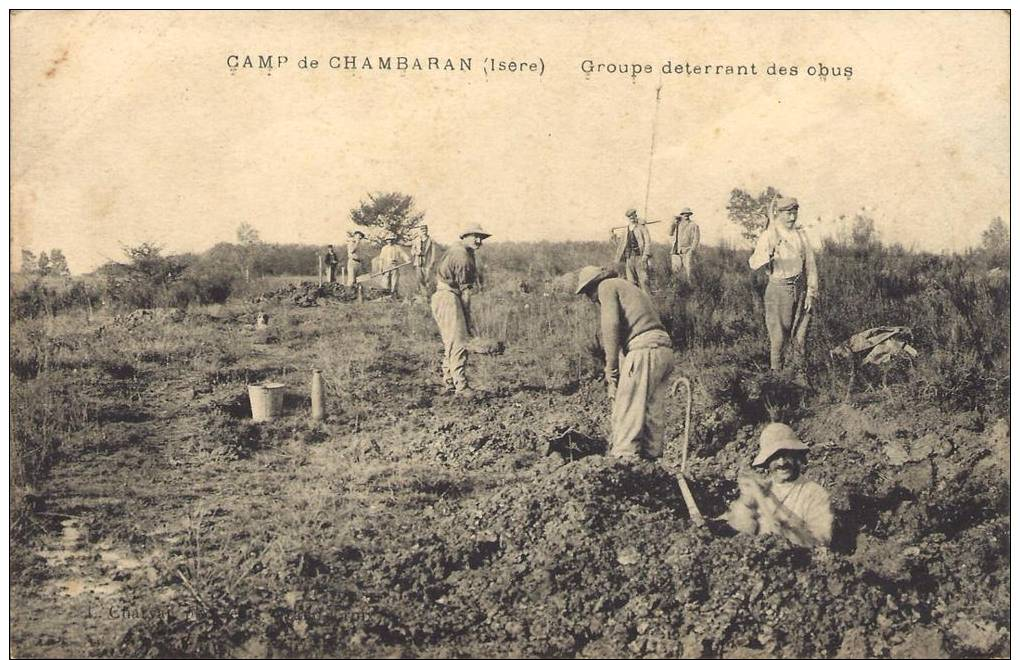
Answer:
[{"xmin": 10, "ymin": 244, "xmax": 1010, "ymax": 657}]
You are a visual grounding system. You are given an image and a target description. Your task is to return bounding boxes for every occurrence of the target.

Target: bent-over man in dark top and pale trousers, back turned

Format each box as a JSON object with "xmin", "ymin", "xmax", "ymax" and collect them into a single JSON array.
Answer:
[{"xmin": 574, "ymin": 266, "xmax": 673, "ymax": 459}]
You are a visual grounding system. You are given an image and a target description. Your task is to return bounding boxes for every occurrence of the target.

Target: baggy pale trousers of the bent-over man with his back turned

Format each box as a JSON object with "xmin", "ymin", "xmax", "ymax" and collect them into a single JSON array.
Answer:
[{"xmin": 609, "ymin": 331, "xmax": 673, "ymax": 459}]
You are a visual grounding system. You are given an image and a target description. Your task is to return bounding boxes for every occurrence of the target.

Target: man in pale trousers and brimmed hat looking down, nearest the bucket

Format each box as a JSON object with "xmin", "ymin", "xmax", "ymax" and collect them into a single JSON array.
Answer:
[{"xmin": 432, "ymin": 223, "xmax": 492, "ymax": 399}]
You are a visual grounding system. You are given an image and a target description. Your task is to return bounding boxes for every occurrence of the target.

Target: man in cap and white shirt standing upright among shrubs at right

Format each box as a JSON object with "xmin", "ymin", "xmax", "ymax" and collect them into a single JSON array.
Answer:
[{"xmin": 748, "ymin": 197, "xmax": 818, "ymax": 378}]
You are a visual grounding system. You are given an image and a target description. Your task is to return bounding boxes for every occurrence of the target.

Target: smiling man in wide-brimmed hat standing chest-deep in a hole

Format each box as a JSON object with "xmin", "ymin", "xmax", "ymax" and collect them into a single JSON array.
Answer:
[{"xmin": 725, "ymin": 422, "xmax": 832, "ymax": 546}]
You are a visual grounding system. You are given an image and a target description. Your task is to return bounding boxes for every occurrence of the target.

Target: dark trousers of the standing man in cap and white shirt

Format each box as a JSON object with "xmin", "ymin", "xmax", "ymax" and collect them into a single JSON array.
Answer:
[{"xmin": 765, "ymin": 274, "xmax": 811, "ymax": 371}]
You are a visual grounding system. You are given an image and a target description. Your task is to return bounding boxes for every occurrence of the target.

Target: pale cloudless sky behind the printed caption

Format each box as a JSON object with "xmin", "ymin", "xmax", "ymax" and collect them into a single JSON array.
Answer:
[{"xmin": 10, "ymin": 11, "xmax": 1010, "ymax": 272}]
